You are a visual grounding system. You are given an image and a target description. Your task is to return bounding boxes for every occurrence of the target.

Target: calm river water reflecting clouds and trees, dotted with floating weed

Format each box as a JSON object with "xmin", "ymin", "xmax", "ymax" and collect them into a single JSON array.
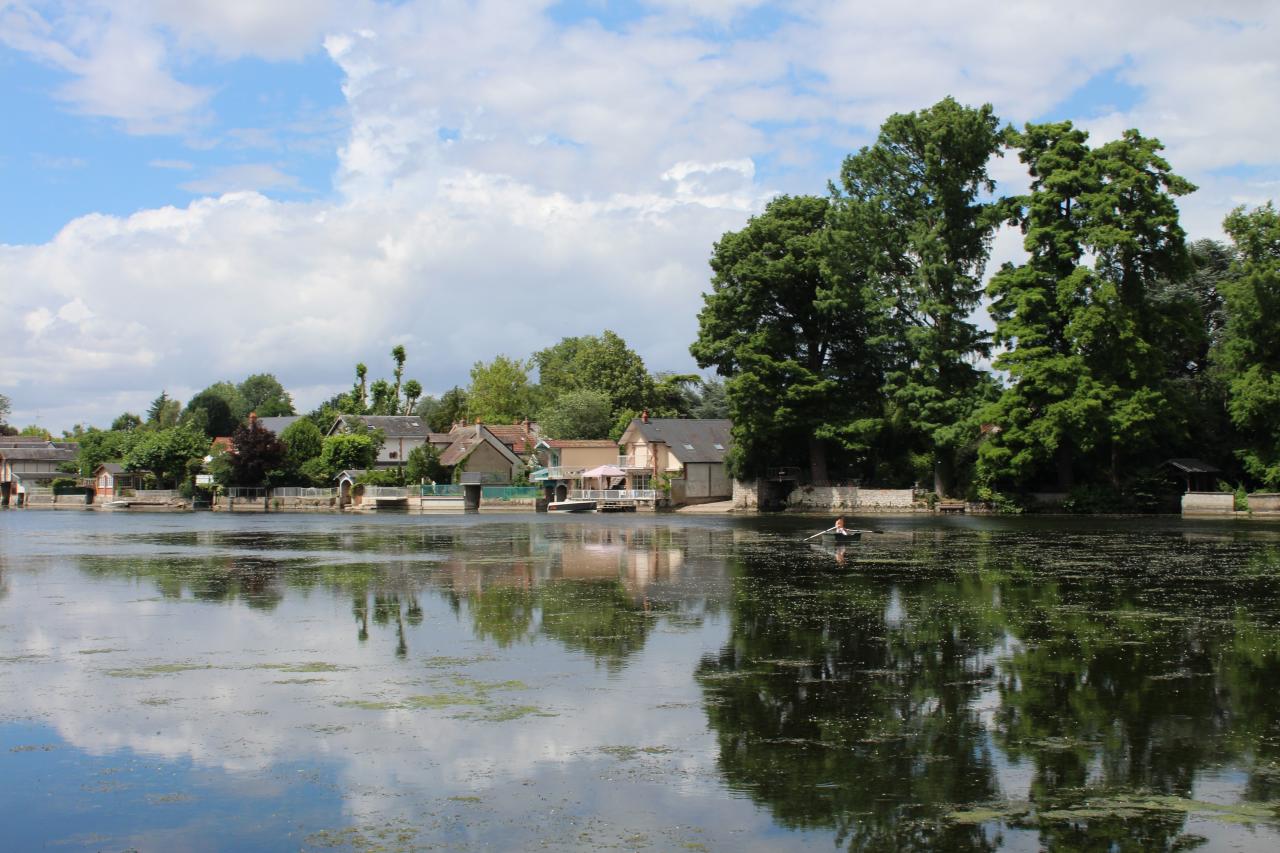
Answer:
[{"xmin": 0, "ymin": 511, "xmax": 1280, "ymax": 850}]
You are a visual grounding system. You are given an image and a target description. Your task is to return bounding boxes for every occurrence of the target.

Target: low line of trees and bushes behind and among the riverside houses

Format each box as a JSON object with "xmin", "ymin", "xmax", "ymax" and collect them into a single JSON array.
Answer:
[{"xmin": 30, "ymin": 330, "xmax": 727, "ymax": 488}]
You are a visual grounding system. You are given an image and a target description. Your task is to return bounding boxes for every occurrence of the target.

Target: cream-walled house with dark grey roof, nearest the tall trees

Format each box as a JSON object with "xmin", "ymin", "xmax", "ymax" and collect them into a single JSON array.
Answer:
[{"xmin": 618, "ymin": 411, "xmax": 733, "ymax": 503}]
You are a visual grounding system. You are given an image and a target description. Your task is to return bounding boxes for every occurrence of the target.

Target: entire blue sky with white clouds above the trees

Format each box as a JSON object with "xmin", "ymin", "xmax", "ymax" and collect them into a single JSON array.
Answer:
[{"xmin": 0, "ymin": 0, "xmax": 1280, "ymax": 433}]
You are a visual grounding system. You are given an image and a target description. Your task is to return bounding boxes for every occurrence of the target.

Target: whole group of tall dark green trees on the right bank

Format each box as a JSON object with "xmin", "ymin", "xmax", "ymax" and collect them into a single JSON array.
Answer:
[{"xmin": 691, "ymin": 97, "xmax": 1280, "ymax": 500}]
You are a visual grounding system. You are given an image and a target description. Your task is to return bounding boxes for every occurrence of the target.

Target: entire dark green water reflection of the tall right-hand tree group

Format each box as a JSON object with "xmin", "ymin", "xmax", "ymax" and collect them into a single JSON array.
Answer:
[{"xmin": 698, "ymin": 534, "xmax": 1280, "ymax": 850}]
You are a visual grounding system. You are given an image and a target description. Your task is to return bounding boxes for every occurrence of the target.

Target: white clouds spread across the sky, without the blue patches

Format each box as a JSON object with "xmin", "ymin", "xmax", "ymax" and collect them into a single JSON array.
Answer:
[{"xmin": 0, "ymin": 0, "xmax": 1280, "ymax": 432}]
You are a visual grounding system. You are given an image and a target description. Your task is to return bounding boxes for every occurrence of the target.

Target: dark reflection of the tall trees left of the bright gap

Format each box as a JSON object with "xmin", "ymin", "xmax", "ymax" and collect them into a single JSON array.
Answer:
[{"xmin": 698, "ymin": 545, "xmax": 1000, "ymax": 850}]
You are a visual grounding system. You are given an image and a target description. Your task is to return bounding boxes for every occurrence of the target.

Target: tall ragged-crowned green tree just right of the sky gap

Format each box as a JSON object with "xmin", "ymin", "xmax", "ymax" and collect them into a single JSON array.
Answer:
[{"xmin": 979, "ymin": 122, "xmax": 1198, "ymax": 488}]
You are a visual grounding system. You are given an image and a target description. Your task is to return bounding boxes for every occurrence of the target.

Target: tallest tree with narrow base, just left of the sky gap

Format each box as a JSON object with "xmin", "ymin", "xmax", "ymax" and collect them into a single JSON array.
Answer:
[{"xmin": 836, "ymin": 97, "xmax": 1002, "ymax": 493}]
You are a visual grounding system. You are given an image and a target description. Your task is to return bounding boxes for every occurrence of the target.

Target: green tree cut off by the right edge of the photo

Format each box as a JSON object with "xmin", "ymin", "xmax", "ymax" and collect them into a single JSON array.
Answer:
[{"xmin": 1216, "ymin": 202, "xmax": 1280, "ymax": 489}]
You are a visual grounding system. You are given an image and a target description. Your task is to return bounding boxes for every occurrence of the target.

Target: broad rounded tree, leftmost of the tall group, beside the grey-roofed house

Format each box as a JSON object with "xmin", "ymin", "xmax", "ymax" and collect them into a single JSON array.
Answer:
[{"xmin": 690, "ymin": 196, "xmax": 879, "ymax": 483}]
